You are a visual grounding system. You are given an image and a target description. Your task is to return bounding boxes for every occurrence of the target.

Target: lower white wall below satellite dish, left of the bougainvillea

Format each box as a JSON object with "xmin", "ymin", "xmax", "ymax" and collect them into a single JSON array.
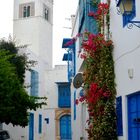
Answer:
[{"xmin": 71, "ymin": 87, "xmax": 88, "ymax": 140}]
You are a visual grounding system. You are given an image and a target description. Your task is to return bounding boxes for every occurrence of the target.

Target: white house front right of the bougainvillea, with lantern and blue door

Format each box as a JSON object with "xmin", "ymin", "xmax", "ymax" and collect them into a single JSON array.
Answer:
[{"xmin": 110, "ymin": 0, "xmax": 140, "ymax": 140}]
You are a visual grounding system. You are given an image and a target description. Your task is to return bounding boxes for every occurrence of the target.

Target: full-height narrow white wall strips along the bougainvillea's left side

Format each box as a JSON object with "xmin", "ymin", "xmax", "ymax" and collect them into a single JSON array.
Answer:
[{"xmin": 71, "ymin": 8, "xmax": 88, "ymax": 140}]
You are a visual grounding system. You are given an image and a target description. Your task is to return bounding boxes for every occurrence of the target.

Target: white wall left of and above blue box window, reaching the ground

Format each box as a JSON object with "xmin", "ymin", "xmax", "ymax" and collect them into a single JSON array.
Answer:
[{"xmin": 44, "ymin": 65, "xmax": 68, "ymax": 140}]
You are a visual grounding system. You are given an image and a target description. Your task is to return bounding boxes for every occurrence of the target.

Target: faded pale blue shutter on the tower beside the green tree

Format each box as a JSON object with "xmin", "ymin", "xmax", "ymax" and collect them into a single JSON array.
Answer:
[{"xmin": 30, "ymin": 70, "xmax": 39, "ymax": 96}]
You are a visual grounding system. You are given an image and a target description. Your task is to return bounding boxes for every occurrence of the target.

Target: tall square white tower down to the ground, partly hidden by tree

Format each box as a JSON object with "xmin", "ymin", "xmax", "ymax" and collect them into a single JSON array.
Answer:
[{"xmin": 8, "ymin": 0, "xmax": 53, "ymax": 140}]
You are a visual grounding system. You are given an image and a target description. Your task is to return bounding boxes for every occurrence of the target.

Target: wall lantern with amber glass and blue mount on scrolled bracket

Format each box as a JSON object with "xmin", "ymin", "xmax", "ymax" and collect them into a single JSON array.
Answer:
[{"xmin": 116, "ymin": 0, "xmax": 140, "ymax": 29}]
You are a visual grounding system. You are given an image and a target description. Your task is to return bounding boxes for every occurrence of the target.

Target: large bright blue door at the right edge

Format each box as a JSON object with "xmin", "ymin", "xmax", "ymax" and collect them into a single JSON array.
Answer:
[{"xmin": 128, "ymin": 92, "xmax": 140, "ymax": 140}]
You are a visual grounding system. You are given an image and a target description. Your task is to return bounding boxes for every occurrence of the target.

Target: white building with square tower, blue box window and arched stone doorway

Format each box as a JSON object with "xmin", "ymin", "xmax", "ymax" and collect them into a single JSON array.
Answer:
[{"xmin": 3, "ymin": 0, "xmax": 71, "ymax": 140}]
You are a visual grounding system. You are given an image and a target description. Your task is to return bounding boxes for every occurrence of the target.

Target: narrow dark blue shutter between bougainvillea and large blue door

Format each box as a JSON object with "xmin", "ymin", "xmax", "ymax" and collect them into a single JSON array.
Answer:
[{"xmin": 116, "ymin": 96, "xmax": 123, "ymax": 136}]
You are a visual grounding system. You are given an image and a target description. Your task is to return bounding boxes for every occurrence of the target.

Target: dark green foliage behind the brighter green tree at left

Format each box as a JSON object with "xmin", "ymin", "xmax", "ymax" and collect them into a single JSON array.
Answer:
[{"xmin": 0, "ymin": 40, "xmax": 35, "ymax": 84}]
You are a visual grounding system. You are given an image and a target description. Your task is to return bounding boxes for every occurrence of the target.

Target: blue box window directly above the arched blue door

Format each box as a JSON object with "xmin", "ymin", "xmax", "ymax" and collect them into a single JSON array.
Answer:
[{"xmin": 58, "ymin": 84, "xmax": 71, "ymax": 108}]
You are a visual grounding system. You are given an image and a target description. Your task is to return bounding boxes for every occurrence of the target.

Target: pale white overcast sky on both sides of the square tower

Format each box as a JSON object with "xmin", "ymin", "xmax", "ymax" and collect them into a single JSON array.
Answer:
[{"xmin": 0, "ymin": 0, "xmax": 78, "ymax": 65}]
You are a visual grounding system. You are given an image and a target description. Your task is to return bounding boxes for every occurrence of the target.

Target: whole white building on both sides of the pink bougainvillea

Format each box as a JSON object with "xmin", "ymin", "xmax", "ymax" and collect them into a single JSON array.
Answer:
[{"xmin": 66, "ymin": 0, "xmax": 140, "ymax": 140}]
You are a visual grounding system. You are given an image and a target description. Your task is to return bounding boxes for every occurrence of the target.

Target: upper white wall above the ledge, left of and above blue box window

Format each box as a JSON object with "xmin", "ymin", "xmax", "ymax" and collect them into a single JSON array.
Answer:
[{"xmin": 46, "ymin": 65, "xmax": 68, "ymax": 108}]
